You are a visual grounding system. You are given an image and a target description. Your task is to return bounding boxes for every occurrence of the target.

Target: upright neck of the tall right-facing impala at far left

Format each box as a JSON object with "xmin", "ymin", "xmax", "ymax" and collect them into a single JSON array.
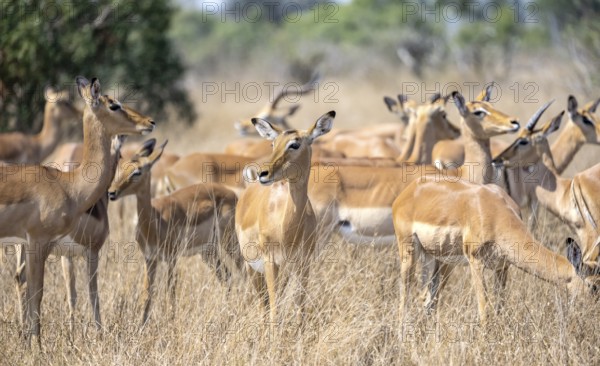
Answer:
[{"xmin": 69, "ymin": 106, "xmax": 115, "ymax": 212}]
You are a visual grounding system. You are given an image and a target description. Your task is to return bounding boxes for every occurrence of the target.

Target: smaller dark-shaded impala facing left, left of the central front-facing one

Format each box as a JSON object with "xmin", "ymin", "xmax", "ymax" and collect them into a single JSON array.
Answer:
[{"xmin": 108, "ymin": 139, "xmax": 241, "ymax": 324}]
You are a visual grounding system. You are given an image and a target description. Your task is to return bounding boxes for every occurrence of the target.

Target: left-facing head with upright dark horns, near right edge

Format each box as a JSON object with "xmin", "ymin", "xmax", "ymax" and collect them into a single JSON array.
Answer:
[{"xmin": 493, "ymin": 102, "xmax": 565, "ymax": 168}]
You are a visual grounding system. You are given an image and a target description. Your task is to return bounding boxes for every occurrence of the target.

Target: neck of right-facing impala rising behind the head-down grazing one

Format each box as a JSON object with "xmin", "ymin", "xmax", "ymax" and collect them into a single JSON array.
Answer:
[{"xmin": 462, "ymin": 121, "xmax": 496, "ymax": 184}]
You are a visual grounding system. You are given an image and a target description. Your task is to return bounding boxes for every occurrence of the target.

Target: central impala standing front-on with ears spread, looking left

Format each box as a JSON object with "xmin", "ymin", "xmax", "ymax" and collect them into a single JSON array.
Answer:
[{"xmin": 235, "ymin": 111, "xmax": 335, "ymax": 322}]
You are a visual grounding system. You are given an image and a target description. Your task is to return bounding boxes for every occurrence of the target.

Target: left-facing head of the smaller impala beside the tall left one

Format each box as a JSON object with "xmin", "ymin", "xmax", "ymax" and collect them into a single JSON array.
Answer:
[{"xmin": 108, "ymin": 139, "xmax": 168, "ymax": 201}]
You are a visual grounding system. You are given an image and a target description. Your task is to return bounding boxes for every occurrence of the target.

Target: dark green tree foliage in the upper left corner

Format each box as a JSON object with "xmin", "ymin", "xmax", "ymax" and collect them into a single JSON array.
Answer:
[{"xmin": 0, "ymin": 0, "xmax": 194, "ymax": 130}]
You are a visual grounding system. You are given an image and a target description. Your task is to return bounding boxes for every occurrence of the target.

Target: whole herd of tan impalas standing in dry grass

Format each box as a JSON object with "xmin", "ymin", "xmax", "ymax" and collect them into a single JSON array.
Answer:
[{"xmin": 0, "ymin": 77, "xmax": 600, "ymax": 345}]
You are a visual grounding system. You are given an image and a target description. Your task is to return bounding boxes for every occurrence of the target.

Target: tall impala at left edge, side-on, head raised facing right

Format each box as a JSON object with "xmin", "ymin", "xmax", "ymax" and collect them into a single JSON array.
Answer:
[{"xmin": 0, "ymin": 76, "xmax": 154, "ymax": 346}]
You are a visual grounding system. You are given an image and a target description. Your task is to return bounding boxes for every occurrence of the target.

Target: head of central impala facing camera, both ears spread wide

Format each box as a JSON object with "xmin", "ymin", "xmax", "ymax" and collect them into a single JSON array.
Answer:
[{"xmin": 252, "ymin": 111, "xmax": 335, "ymax": 185}]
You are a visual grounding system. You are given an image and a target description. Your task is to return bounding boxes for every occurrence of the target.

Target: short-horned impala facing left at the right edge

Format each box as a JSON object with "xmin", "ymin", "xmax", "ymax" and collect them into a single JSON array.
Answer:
[{"xmin": 495, "ymin": 113, "xmax": 600, "ymax": 266}]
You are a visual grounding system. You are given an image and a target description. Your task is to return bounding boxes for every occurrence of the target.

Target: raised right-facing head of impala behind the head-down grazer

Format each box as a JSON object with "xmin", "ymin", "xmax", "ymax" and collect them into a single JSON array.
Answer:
[{"xmin": 452, "ymin": 87, "xmax": 519, "ymax": 139}]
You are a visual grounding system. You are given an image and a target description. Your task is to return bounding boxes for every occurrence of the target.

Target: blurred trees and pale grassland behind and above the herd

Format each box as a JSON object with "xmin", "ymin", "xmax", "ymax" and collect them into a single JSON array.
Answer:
[{"xmin": 0, "ymin": 0, "xmax": 600, "ymax": 150}]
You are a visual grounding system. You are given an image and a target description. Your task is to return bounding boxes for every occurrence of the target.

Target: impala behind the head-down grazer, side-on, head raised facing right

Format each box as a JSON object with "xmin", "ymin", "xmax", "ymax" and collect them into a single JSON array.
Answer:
[{"xmin": 309, "ymin": 87, "xmax": 519, "ymax": 245}]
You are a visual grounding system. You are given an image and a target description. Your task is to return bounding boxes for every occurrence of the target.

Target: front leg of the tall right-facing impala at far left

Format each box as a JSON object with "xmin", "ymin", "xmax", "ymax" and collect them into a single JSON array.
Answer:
[{"xmin": 25, "ymin": 239, "xmax": 50, "ymax": 350}]
